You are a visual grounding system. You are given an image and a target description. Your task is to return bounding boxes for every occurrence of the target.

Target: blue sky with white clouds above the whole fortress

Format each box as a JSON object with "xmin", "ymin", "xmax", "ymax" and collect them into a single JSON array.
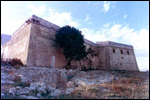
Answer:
[{"xmin": 1, "ymin": 1, "xmax": 149, "ymax": 71}]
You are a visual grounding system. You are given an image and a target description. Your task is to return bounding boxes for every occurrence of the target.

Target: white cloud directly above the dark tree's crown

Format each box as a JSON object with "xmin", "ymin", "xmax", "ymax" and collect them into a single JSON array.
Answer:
[{"xmin": 43, "ymin": 8, "xmax": 79, "ymax": 27}]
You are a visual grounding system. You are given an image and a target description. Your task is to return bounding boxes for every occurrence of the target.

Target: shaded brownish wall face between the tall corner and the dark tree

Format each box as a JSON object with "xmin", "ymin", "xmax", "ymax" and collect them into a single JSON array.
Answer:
[{"xmin": 27, "ymin": 23, "xmax": 66, "ymax": 68}]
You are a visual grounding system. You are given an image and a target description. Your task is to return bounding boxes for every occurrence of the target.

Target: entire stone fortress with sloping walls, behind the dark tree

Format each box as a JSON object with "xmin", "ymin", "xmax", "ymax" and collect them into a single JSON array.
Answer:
[{"xmin": 1, "ymin": 15, "xmax": 139, "ymax": 71}]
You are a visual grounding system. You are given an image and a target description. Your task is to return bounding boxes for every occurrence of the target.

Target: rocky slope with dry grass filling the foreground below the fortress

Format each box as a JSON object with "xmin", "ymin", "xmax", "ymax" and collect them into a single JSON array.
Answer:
[{"xmin": 1, "ymin": 66, "xmax": 149, "ymax": 99}]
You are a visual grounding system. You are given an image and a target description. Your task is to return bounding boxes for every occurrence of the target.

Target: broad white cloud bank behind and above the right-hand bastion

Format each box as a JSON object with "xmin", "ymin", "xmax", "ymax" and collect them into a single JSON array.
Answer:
[{"xmin": 81, "ymin": 23, "xmax": 149, "ymax": 70}]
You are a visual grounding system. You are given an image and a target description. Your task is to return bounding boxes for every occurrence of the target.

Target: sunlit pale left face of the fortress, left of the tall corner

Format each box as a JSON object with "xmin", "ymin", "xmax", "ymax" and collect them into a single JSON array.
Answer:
[{"xmin": 2, "ymin": 24, "xmax": 31, "ymax": 64}]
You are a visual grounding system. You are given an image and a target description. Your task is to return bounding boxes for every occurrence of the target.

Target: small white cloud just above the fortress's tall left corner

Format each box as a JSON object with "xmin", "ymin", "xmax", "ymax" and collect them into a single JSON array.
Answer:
[{"xmin": 27, "ymin": 4, "xmax": 46, "ymax": 16}]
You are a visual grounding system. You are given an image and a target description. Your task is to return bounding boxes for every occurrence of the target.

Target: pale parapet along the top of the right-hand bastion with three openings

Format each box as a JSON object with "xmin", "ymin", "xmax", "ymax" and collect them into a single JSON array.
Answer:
[{"xmin": 96, "ymin": 41, "xmax": 133, "ymax": 49}]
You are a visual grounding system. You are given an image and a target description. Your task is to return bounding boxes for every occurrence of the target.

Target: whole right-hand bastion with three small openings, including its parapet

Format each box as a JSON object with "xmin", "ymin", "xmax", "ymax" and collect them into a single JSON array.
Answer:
[{"xmin": 97, "ymin": 41, "xmax": 139, "ymax": 71}]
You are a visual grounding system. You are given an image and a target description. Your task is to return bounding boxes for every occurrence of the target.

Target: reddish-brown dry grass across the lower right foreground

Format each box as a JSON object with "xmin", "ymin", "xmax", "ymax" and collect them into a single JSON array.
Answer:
[{"xmin": 49, "ymin": 77, "xmax": 149, "ymax": 99}]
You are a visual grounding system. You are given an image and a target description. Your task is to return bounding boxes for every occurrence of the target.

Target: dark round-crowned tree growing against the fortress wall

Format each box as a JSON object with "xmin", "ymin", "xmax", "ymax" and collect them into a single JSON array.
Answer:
[{"xmin": 55, "ymin": 25, "xmax": 87, "ymax": 68}]
